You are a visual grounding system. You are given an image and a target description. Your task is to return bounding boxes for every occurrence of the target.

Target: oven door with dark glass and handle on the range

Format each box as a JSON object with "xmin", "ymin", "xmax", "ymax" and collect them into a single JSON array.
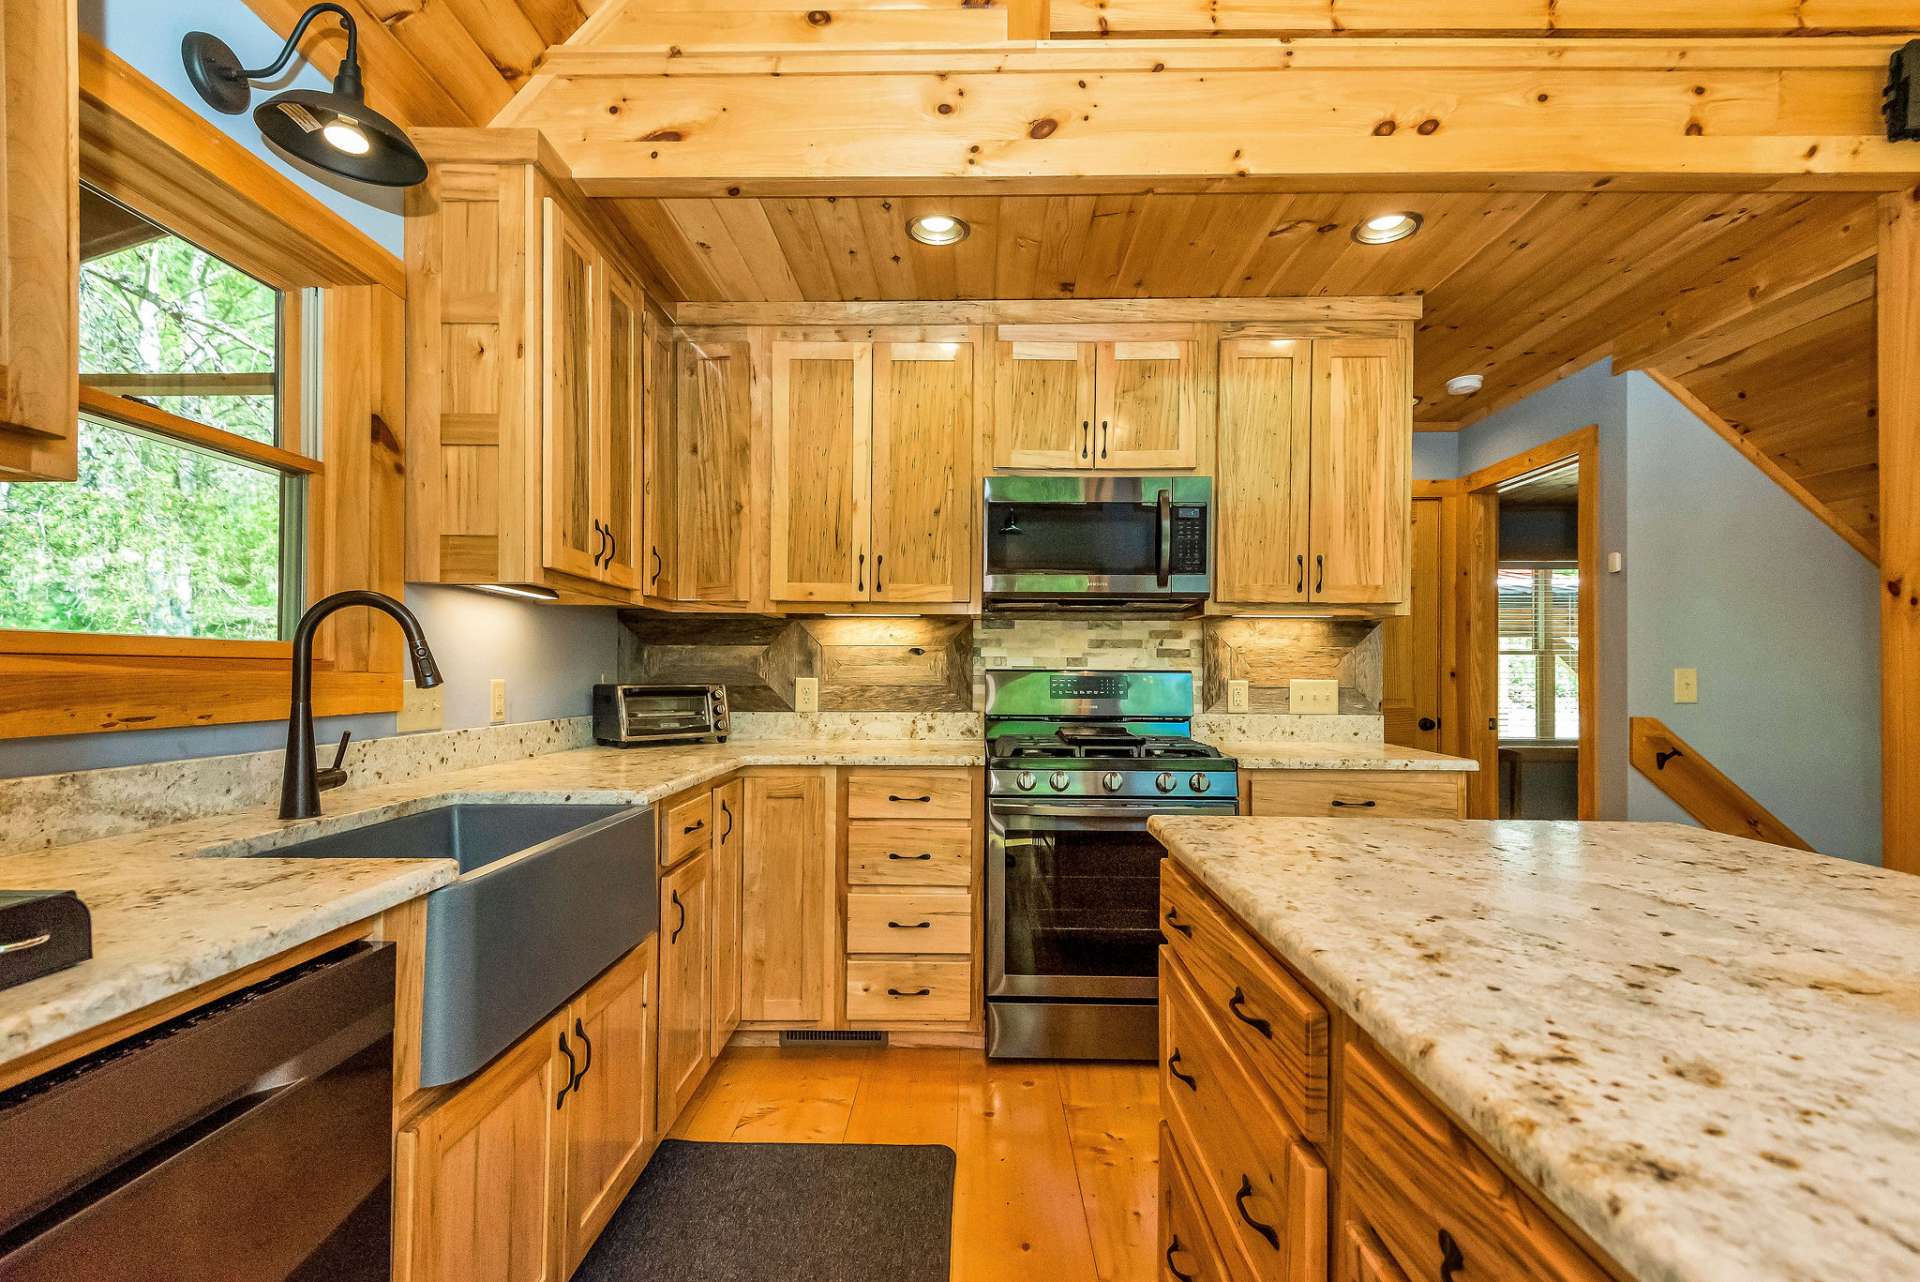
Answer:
[{"xmin": 987, "ymin": 800, "xmax": 1235, "ymax": 1002}]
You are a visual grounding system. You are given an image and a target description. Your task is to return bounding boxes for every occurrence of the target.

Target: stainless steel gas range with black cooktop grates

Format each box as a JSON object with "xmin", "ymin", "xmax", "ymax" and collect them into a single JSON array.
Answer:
[{"xmin": 987, "ymin": 670, "xmax": 1238, "ymax": 1059}]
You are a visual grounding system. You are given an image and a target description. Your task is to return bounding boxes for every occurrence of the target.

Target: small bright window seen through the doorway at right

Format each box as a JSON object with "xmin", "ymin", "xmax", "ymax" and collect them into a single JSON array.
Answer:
[{"xmin": 1498, "ymin": 562, "xmax": 1580, "ymax": 741}]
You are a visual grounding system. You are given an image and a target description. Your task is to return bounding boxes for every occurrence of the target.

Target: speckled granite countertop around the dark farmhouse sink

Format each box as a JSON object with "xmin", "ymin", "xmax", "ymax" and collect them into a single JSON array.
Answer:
[{"xmin": 0, "ymin": 739, "xmax": 985, "ymax": 1063}]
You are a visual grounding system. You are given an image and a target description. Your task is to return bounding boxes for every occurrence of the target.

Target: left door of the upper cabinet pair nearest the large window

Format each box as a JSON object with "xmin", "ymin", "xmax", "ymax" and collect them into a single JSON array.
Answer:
[{"xmin": 540, "ymin": 196, "xmax": 603, "ymax": 578}]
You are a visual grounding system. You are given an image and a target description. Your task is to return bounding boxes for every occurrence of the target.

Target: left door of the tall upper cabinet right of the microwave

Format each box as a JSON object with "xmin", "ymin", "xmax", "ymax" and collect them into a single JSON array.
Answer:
[{"xmin": 1213, "ymin": 338, "xmax": 1313, "ymax": 605}]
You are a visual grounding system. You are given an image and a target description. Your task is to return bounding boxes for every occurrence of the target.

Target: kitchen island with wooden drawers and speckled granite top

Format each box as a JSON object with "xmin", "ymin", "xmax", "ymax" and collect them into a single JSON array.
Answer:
[{"xmin": 1152, "ymin": 818, "xmax": 1920, "ymax": 1282}]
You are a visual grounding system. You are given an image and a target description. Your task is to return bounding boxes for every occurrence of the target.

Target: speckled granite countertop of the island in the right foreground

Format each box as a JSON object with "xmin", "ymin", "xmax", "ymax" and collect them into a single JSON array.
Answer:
[{"xmin": 1152, "ymin": 818, "xmax": 1920, "ymax": 1282}]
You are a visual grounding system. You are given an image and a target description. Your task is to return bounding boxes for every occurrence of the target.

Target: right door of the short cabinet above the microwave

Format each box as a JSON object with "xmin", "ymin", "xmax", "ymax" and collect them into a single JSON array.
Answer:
[{"xmin": 1094, "ymin": 340, "xmax": 1200, "ymax": 468}]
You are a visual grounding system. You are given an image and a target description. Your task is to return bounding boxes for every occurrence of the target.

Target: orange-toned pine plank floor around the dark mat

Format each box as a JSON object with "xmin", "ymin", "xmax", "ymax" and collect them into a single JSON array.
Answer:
[{"xmin": 672, "ymin": 1046, "xmax": 1160, "ymax": 1282}]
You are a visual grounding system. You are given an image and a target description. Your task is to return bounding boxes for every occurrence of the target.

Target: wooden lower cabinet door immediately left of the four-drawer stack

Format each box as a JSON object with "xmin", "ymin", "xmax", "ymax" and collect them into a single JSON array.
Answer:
[{"xmin": 739, "ymin": 772, "xmax": 835, "ymax": 1025}]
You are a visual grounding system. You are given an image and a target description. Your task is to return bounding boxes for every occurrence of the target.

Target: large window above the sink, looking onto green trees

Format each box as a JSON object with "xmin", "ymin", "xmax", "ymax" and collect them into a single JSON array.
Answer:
[{"xmin": 0, "ymin": 186, "xmax": 311, "ymax": 641}]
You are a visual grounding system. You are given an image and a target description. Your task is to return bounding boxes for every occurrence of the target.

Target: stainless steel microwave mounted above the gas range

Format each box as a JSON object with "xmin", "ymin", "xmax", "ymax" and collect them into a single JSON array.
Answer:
[{"xmin": 981, "ymin": 476, "xmax": 1213, "ymax": 612}]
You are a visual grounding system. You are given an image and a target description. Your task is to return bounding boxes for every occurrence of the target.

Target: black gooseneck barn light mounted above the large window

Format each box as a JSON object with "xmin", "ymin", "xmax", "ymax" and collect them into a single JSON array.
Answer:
[{"xmin": 180, "ymin": 4, "xmax": 426, "ymax": 186}]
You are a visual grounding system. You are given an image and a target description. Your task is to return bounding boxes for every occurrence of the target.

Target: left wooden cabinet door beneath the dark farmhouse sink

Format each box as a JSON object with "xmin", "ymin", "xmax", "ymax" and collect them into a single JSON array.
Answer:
[{"xmin": 394, "ymin": 1009, "xmax": 574, "ymax": 1282}]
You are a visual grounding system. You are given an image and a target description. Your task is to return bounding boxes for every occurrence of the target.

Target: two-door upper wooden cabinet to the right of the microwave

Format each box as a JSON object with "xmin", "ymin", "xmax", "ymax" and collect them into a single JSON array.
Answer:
[{"xmin": 1213, "ymin": 334, "xmax": 1413, "ymax": 606}]
